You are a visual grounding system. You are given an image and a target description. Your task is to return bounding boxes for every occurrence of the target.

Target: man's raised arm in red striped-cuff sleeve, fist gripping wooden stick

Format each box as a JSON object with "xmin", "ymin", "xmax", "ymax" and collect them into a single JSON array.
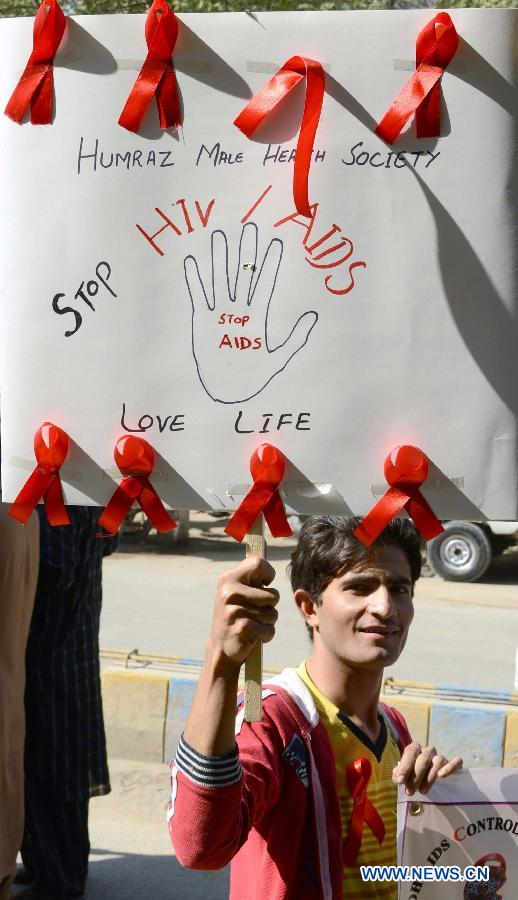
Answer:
[{"xmin": 168, "ymin": 557, "xmax": 279, "ymax": 869}]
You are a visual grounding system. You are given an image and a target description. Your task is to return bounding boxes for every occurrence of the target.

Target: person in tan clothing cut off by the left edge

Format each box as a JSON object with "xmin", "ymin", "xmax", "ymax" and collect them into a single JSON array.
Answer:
[{"xmin": 0, "ymin": 506, "xmax": 39, "ymax": 900}]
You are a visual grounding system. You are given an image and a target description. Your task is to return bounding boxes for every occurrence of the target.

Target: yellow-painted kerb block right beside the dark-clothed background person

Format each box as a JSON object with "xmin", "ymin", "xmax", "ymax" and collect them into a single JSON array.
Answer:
[{"xmin": 102, "ymin": 669, "xmax": 170, "ymax": 762}]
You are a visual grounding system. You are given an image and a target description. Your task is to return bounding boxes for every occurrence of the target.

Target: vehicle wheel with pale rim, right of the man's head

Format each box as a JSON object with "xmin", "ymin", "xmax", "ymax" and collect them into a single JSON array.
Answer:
[{"xmin": 427, "ymin": 522, "xmax": 492, "ymax": 581}]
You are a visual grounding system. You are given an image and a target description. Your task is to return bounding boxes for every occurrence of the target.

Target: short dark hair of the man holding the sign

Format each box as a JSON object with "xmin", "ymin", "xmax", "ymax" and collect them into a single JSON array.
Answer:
[{"xmin": 289, "ymin": 516, "xmax": 422, "ymax": 636}]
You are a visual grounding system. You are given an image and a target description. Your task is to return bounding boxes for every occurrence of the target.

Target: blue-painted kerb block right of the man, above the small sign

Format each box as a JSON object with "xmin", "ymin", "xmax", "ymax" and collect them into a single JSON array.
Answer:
[{"xmin": 428, "ymin": 703, "xmax": 506, "ymax": 768}]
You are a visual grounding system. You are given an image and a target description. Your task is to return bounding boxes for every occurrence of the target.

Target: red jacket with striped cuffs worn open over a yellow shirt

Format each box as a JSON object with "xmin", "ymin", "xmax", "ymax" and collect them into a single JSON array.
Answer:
[{"xmin": 168, "ymin": 669, "xmax": 410, "ymax": 900}]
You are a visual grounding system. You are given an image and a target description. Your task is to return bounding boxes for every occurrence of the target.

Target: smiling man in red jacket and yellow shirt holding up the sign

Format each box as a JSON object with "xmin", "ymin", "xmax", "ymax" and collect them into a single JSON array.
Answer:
[{"xmin": 169, "ymin": 516, "xmax": 461, "ymax": 900}]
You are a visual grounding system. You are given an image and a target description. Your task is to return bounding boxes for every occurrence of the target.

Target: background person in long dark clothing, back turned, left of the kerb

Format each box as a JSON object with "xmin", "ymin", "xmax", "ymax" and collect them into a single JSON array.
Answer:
[{"xmin": 16, "ymin": 506, "xmax": 117, "ymax": 900}]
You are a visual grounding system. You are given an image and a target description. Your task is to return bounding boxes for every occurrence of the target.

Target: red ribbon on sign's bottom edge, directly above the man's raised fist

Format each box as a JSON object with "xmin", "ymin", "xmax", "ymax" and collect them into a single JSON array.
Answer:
[{"xmin": 225, "ymin": 444, "xmax": 293, "ymax": 541}]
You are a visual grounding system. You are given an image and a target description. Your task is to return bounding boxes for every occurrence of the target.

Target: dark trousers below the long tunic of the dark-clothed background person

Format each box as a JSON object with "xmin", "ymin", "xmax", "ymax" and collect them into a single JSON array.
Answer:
[{"xmin": 21, "ymin": 771, "xmax": 90, "ymax": 900}]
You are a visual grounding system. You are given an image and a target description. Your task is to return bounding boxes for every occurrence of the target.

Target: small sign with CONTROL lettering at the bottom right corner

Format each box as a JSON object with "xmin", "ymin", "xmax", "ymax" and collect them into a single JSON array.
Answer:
[{"xmin": 398, "ymin": 769, "xmax": 518, "ymax": 900}]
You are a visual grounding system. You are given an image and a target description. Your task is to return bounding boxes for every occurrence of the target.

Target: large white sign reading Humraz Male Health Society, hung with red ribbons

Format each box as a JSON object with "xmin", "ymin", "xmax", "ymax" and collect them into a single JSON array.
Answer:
[{"xmin": 0, "ymin": 9, "xmax": 518, "ymax": 519}]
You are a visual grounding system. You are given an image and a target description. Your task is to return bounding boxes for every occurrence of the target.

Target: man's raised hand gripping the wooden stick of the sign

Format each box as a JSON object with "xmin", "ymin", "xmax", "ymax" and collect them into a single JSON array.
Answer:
[{"xmin": 207, "ymin": 556, "xmax": 279, "ymax": 675}]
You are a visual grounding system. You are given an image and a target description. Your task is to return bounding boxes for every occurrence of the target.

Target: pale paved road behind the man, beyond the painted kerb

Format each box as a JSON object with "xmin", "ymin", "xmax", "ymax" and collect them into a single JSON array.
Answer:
[{"xmin": 101, "ymin": 514, "xmax": 518, "ymax": 690}]
